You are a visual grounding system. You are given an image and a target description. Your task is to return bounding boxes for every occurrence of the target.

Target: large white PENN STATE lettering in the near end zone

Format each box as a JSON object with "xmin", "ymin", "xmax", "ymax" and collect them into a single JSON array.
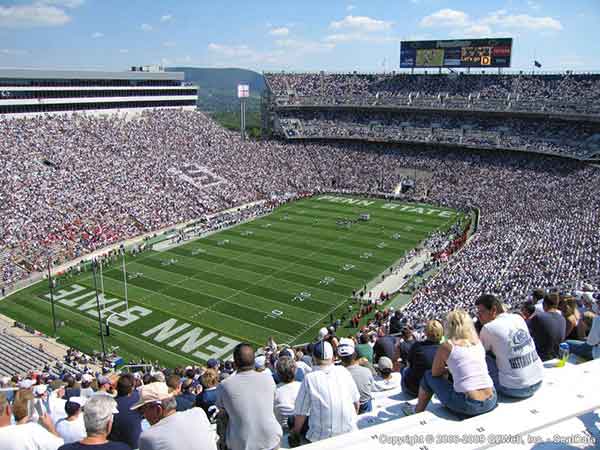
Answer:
[{"xmin": 44, "ymin": 284, "xmax": 239, "ymax": 361}]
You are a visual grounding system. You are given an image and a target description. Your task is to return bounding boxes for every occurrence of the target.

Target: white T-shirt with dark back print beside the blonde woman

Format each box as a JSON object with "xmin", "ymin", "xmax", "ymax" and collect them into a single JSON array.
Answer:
[{"xmin": 479, "ymin": 313, "xmax": 544, "ymax": 389}]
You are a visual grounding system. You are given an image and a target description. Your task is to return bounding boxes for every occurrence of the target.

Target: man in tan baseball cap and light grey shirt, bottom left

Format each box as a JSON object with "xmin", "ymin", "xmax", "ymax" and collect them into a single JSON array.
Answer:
[{"xmin": 131, "ymin": 382, "xmax": 217, "ymax": 450}]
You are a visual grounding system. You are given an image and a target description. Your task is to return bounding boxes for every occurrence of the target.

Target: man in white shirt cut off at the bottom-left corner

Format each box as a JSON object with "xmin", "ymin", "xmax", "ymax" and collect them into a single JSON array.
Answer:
[{"xmin": 0, "ymin": 393, "xmax": 63, "ymax": 450}]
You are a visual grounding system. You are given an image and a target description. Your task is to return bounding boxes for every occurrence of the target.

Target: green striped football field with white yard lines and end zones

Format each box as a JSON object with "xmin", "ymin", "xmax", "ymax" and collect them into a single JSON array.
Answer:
[{"xmin": 0, "ymin": 195, "xmax": 462, "ymax": 366}]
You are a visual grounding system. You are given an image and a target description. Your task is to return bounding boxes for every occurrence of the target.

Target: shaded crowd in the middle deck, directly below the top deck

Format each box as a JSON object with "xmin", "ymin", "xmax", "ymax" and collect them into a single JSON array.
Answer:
[{"xmin": 279, "ymin": 110, "xmax": 600, "ymax": 158}]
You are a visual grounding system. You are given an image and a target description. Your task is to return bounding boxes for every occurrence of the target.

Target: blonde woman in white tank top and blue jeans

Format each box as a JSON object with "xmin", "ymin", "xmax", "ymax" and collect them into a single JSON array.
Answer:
[{"xmin": 415, "ymin": 309, "xmax": 498, "ymax": 416}]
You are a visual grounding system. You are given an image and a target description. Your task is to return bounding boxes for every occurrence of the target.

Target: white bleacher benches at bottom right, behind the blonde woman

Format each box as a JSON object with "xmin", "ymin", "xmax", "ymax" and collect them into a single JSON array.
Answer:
[{"xmin": 303, "ymin": 356, "xmax": 600, "ymax": 450}]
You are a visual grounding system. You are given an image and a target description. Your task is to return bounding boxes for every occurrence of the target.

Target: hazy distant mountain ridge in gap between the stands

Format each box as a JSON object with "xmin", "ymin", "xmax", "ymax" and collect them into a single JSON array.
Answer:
[{"xmin": 165, "ymin": 67, "xmax": 265, "ymax": 95}]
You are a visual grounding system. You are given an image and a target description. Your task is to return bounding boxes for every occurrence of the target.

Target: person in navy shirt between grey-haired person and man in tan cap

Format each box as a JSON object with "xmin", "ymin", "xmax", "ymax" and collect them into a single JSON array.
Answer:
[{"xmin": 108, "ymin": 373, "xmax": 142, "ymax": 448}]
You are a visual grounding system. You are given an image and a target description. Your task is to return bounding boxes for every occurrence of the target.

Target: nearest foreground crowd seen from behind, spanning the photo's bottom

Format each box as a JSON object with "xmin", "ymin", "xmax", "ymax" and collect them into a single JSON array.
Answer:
[{"xmin": 0, "ymin": 283, "xmax": 600, "ymax": 450}]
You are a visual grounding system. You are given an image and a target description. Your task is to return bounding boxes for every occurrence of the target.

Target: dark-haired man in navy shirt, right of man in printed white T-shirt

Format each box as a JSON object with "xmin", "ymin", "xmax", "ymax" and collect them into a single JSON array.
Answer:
[{"xmin": 529, "ymin": 293, "xmax": 567, "ymax": 361}]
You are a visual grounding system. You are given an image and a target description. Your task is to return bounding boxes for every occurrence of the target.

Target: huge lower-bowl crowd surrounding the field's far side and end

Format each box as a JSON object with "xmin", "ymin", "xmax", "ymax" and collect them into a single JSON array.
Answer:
[{"xmin": 0, "ymin": 111, "xmax": 600, "ymax": 316}]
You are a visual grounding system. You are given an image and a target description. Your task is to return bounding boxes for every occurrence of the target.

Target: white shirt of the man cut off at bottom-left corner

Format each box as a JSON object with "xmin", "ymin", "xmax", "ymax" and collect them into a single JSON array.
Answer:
[{"xmin": 0, "ymin": 422, "xmax": 63, "ymax": 450}]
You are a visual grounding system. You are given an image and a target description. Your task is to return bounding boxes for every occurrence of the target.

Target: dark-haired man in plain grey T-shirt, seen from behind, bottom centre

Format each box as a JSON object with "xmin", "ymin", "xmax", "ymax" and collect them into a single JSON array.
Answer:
[{"xmin": 216, "ymin": 343, "xmax": 282, "ymax": 450}]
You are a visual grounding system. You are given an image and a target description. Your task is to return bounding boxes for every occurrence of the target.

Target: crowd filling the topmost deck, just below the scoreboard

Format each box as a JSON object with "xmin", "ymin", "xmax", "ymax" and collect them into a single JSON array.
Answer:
[{"xmin": 266, "ymin": 73, "xmax": 600, "ymax": 115}]
